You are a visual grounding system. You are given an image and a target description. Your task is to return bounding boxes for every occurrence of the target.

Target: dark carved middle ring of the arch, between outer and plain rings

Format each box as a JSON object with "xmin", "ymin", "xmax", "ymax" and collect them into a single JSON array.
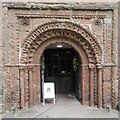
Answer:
[{"xmin": 28, "ymin": 30, "xmax": 96, "ymax": 64}]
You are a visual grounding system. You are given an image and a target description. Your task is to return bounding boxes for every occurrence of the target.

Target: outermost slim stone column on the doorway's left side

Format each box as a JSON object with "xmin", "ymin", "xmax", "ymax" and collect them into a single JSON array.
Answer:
[{"xmin": 20, "ymin": 67, "xmax": 25, "ymax": 108}]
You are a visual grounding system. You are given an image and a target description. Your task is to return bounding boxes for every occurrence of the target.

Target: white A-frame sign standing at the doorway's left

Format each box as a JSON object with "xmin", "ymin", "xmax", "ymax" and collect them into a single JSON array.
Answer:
[{"xmin": 43, "ymin": 82, "xmax": 55, "ymax": 105}]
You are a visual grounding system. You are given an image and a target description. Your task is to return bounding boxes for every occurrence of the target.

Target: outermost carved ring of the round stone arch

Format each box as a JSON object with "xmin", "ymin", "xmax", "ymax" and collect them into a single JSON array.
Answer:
[{"xmin": 21, "ymin": 21, "xmax": 102, "ymax": 64}]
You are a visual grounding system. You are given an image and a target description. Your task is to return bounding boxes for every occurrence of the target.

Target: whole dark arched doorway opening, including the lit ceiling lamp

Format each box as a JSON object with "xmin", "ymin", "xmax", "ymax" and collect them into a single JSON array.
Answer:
[{"xmin": 41, "ymin": 43, "xmax": 81, "ymax": 101}]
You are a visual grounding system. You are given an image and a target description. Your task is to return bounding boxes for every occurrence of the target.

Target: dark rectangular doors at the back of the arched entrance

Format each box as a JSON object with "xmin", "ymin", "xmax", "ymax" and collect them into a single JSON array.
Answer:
[{"xmin": 44, "ymin": 49, "xmax": 75, "ymax": 94}]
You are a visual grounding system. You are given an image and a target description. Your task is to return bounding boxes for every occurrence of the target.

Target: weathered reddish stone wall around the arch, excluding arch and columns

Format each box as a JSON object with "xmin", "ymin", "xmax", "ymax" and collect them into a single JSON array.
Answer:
[{"xmin": 0, "ymin": 3, "xmax": 120, "ymax": 110}]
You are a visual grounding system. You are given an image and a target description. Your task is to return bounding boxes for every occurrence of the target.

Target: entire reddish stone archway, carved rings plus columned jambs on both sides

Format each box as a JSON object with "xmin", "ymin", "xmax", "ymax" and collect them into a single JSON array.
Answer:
[{"xmin": 20, "ymin": 21, "xmax": 102, "ymax": 107}]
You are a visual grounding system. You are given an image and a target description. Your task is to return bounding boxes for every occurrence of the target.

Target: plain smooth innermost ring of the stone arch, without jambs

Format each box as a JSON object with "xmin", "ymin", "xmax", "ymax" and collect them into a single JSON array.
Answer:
[{"xmin": 30, "ymin": 37, "xmax": 89, "ymax": 66}]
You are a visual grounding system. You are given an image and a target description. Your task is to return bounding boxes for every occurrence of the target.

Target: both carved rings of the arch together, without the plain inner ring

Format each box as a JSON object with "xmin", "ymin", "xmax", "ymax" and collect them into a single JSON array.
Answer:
[{"xmin": 21, "ymin": 21, "xmax": 102, "ymax": 64}]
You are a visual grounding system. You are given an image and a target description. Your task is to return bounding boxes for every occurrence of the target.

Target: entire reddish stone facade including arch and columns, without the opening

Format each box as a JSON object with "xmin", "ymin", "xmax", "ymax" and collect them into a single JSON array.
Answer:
[{"xmin": 0, "ymin": 3, "xmax": 118, "ymax": 111}]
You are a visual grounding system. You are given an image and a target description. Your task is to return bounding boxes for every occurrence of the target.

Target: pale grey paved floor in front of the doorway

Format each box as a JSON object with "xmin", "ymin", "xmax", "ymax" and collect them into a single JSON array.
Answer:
[{"xmin": 3, "ymin": 95, "xmax": 118, "ymax": 118}]
